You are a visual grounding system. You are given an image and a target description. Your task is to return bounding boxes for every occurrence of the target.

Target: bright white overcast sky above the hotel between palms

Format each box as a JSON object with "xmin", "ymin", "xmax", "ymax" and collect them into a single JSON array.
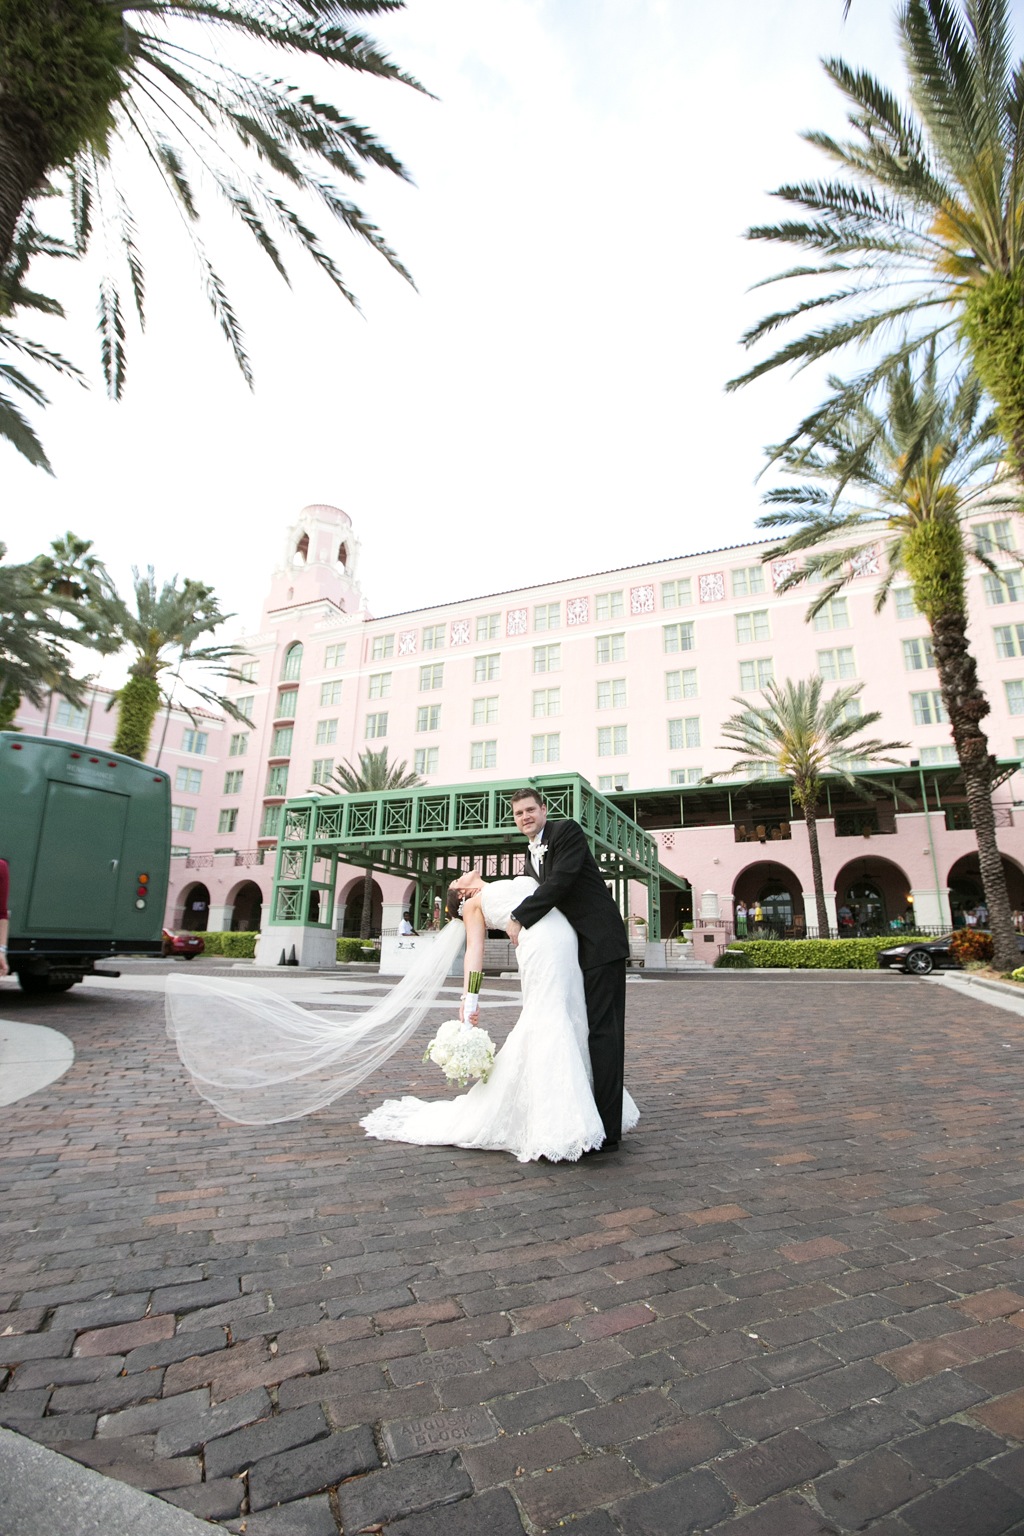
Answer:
[{"xmin": 0, "ymin": 0, "xmax": 1024, "ymax": 645}]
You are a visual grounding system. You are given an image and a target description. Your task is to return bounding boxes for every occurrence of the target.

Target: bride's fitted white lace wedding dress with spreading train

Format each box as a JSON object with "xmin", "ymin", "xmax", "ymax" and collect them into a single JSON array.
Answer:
[{"xmin": 359, "ymin": 876, "xmax": 640, "ymax": 1163}]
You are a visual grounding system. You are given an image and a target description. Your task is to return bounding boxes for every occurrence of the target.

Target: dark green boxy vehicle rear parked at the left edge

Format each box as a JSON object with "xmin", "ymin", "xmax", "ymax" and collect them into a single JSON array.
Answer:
[{"xmin": 0, "ymin": 731, "xmax": 170, "ymax": 992}]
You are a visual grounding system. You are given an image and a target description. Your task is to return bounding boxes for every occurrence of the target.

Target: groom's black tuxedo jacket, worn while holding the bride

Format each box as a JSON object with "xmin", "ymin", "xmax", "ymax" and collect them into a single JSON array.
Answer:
[{"xmin": 513, "ymin": 819, "xmax": 629, "ymax": 971}]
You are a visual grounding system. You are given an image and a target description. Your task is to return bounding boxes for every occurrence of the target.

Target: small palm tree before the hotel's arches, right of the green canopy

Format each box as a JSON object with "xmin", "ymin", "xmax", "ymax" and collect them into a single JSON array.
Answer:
[{"xmin": 708, "ymin": 677, "xmax": 907, "ymax": 937}]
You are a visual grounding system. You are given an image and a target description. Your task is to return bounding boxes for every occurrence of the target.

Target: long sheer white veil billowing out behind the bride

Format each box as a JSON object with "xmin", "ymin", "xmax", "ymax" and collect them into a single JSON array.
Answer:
[{"xmin": 166, "ymin": 922, "xmax": 465, "ymax": 1126}]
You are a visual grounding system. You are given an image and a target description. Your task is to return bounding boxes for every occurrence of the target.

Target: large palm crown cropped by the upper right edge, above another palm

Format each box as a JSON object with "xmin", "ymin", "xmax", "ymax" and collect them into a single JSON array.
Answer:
[{"xmin": 728, "ymin": 0, "xmax": 1024, "ymax": 472}]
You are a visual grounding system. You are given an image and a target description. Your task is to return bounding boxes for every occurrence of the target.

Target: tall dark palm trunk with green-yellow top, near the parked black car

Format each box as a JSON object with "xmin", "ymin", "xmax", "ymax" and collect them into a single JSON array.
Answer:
[{"xmin": 906, "ymin": 518, "xmax": 1021, "ymax": 971}]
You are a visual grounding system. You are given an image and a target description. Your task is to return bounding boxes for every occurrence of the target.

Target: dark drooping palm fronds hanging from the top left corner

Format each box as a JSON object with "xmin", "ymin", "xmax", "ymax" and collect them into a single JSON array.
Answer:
[{"xmin": 0, "ymin": 0, "xmax": 424, "ymax": 414}]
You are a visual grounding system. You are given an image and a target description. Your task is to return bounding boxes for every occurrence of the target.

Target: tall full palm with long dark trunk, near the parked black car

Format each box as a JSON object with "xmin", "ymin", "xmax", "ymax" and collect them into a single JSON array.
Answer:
[{"xmin": 760, "ymin": 346, "xmax": 1019, "ymax": 971}]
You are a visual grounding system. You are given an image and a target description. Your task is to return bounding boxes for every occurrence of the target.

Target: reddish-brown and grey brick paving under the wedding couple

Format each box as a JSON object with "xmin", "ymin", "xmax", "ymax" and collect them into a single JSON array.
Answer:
[{"xmin": 0, "ymin": 969, "xmax": 1024, "ymax": 1536}]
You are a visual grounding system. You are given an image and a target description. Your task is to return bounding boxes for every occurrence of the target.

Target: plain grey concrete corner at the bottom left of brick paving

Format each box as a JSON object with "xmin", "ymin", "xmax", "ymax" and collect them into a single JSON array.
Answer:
[{"xmin": 0, "ymin": 1428, "xmax": 210, "ymax": 1536}]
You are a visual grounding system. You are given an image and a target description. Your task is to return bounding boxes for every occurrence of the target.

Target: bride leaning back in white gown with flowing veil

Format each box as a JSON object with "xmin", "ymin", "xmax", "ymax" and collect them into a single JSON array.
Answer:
[{"xmin": 167, "ymin": 874, "xmax": 639, "ymax": 1163}]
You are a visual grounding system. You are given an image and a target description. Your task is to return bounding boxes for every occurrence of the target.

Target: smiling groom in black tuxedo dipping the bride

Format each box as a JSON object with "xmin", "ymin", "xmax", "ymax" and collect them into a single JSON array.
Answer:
[{"xmin": 508, "ymin": 790, "xmax": 629, "ymax": 1152}]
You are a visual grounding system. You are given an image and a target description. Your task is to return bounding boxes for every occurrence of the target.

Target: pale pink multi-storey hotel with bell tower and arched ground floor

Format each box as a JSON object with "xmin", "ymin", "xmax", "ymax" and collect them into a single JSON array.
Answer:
[{"xmin": 18, "ymin": 505, "xmax": 1024, "ymax": 937}]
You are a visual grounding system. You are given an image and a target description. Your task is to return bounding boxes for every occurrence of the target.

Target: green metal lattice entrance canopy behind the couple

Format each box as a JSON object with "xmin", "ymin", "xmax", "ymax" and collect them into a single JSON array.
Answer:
[{"xmin": 270, "ymin": 774, "xmax": 689, "ymax": 938}]
